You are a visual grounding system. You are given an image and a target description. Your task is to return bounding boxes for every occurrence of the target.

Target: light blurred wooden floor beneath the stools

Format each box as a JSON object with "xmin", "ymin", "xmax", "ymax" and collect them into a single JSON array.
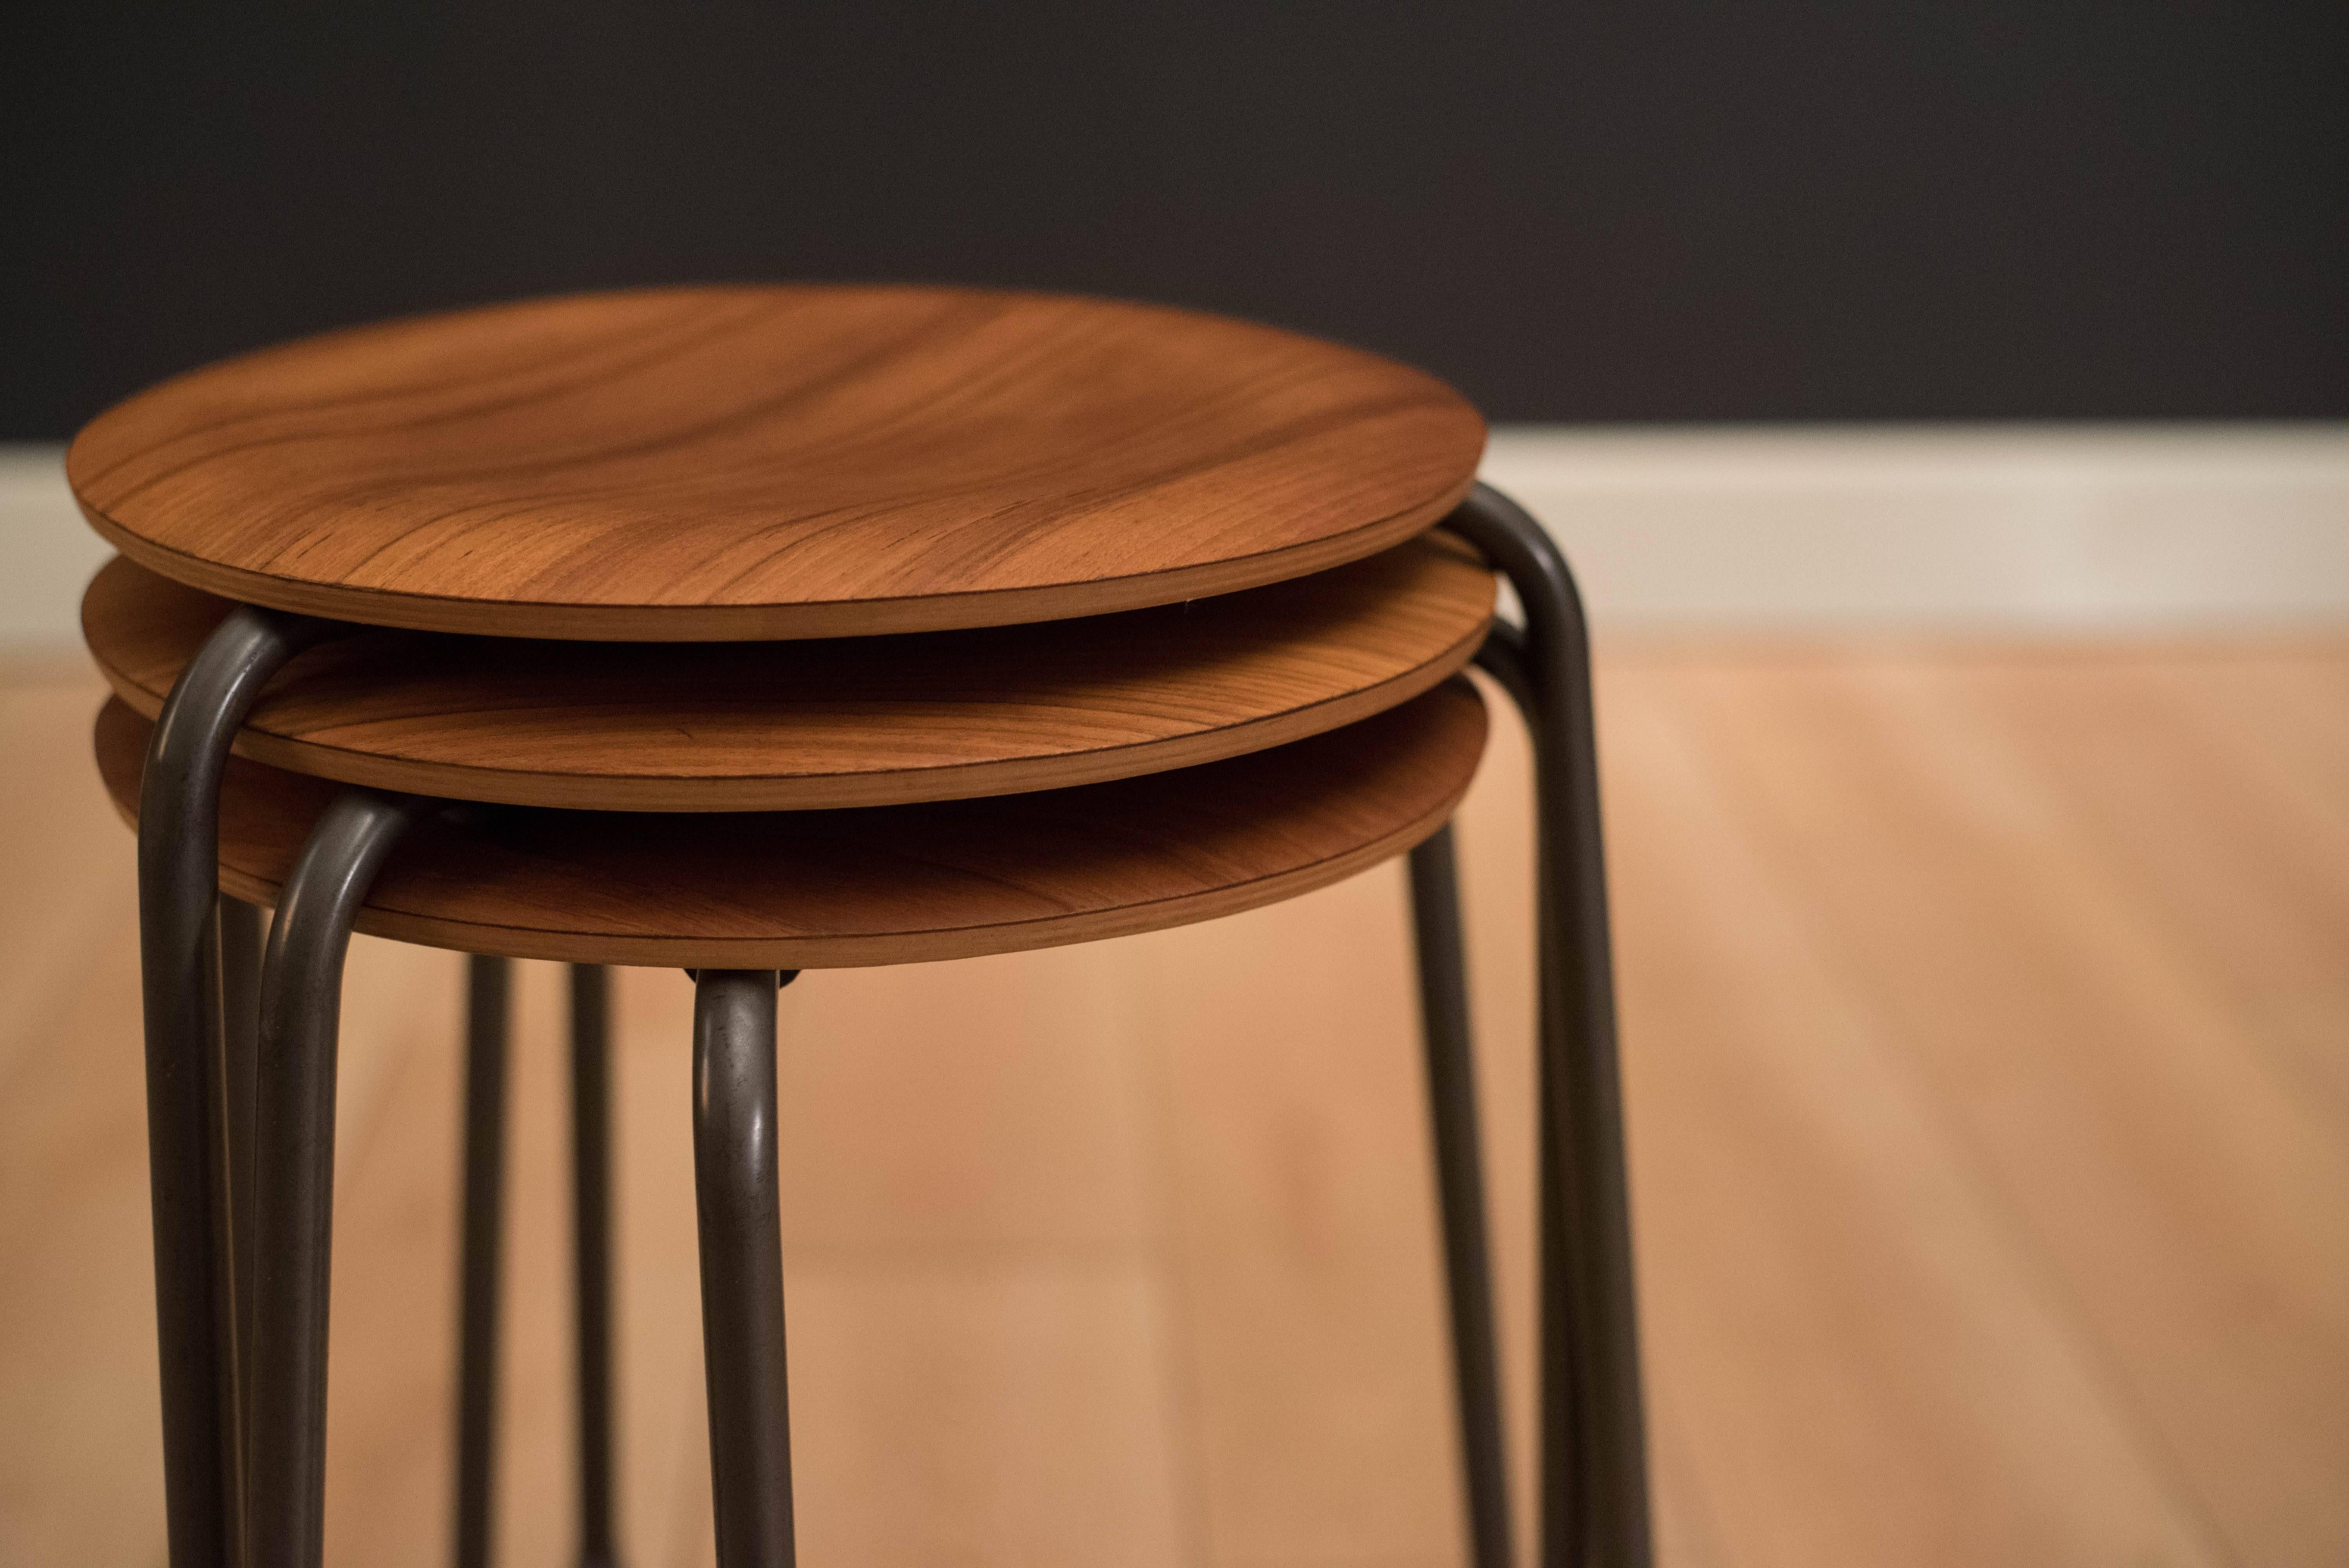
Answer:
[{"xmin": 0, "ymin": 643, "xmax": 2349, "ymax": 1568}]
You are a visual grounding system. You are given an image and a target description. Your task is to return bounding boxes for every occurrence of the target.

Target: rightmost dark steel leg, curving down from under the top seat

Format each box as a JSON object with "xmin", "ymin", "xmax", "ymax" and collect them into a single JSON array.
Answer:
[{"xmin": 1445, "ymin": 483, "xmax": 1649, "ymax": 1568}]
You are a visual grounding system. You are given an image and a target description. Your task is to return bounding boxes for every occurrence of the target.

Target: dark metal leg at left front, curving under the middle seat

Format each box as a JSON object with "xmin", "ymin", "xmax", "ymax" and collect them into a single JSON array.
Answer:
[{"xmin": 244, "ymin": 789, "xmax": 432, "ymax": 1568}]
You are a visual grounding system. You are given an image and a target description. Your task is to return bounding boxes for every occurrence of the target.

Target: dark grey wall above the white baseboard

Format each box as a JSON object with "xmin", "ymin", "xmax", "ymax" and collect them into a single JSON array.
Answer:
[{"xmin": 0, "ymin": 0, "xmax": 2349, "ymax": 437}]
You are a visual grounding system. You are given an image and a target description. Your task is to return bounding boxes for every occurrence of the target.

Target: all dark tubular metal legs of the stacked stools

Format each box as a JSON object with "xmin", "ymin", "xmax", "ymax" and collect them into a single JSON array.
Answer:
[{"xmin": 119, "ymin": 483, "xmax": 1651, "ymax": 1568}]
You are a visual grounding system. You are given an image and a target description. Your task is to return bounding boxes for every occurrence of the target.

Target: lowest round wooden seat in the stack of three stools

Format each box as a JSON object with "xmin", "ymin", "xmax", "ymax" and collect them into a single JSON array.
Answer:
[{"xmin": 96, "ymin": 681, "xmax": 1485, "ymax": 969}]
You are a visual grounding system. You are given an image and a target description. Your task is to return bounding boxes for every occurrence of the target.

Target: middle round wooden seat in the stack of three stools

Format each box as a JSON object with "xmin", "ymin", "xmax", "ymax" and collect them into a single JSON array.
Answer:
[{"xmin": 82, "ymin": 533, "xmax": 1494, "ymax": 812}]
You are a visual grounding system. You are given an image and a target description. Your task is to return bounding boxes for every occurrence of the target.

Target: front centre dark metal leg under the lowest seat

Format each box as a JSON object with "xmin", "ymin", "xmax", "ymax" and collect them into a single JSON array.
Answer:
[{"xmin": 693, "ymin": 969, "xmax": 794, "ymax": 1568}]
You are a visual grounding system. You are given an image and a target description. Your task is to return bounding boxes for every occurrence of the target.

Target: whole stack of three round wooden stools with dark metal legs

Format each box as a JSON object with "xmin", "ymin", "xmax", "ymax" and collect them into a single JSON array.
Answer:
[{"xmin": 68, "ymin": 286, "xmax": 1649, "ymax": 1568}]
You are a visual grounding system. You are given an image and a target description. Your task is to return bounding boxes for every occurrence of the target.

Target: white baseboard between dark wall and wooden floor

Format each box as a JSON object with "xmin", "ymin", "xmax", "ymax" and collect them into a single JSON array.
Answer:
[{"xmin": 0, "ymin": 422, "xmax": 2349, "ymax": 652}]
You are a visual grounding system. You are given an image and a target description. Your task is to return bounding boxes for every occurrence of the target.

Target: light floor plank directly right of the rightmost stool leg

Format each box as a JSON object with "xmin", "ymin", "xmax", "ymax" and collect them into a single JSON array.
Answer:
[{"xmin": 1604, "ymin": 674, "xmax": 2222, "ymax": 1568}]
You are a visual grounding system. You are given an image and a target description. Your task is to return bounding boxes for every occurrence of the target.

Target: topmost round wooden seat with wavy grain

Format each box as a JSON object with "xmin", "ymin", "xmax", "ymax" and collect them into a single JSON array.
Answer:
[{"xmin": 66, "ymin": 286, "xmax": 1485, "ymax": 641}]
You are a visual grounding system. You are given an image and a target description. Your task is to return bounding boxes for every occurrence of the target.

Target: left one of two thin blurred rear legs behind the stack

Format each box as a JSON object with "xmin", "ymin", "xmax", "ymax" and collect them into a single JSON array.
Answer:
[{"xmin": 453, "ymin": 955, "xmax": 515, "ymax": 1568}]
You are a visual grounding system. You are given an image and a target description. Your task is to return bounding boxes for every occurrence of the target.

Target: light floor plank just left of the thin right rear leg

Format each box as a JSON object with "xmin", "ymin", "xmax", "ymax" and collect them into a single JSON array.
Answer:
[{"xmin": 1132, "ymin": 868, "xmax": 1459, "ymax": 1563}]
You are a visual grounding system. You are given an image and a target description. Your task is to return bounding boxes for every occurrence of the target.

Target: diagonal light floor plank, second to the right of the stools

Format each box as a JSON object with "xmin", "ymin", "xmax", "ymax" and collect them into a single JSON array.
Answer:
[{"xmin": 1672, "ymin": 664, "xmax": 2349, "ymax": 1563}]
